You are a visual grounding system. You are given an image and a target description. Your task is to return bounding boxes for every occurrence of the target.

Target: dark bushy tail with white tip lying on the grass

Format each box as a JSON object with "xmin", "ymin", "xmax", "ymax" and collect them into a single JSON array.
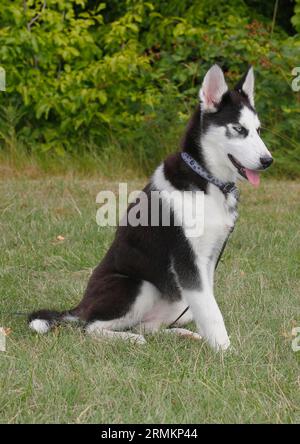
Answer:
[{"xmin": 28, "ymin": 310, "xmax": 78, "ymax": 334}]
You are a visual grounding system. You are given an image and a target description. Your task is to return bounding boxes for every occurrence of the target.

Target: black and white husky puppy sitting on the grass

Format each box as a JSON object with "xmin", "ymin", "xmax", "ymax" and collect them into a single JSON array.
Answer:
[{"xmin": 29, "ymin": 65, "xmax": 273, "ymax": 350}]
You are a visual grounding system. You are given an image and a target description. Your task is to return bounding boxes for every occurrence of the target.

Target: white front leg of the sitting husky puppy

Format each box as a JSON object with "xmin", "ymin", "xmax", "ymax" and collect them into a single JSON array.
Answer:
[{"xmin": 184, "ymin": 267, "xmax": 230, "ymax": 350}]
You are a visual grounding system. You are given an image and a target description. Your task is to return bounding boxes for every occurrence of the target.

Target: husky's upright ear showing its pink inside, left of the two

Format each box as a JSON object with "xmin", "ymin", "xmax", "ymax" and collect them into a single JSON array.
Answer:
[{"xmin": 199, "ymin": 65, "xmax": 228, "ymax": 112}]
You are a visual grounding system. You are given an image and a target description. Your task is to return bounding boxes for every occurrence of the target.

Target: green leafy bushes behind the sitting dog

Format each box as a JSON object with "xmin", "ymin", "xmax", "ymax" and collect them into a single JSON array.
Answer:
[{"xmin": 0, "ymin": 0, "xmax": 300, "ymax": 175}]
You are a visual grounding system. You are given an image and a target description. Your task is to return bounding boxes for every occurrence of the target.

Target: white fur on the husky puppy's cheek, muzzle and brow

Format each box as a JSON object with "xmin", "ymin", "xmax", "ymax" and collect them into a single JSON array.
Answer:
[{"xmin": 201, "ymin": 106, "xmax": 271, "ymax": 180}]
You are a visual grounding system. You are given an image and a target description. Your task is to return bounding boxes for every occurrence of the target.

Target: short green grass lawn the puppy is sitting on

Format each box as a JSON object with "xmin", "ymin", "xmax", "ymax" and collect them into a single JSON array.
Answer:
[{"xmin": 0, "ymin": 177, "xmax": 300, "ymax": 423}]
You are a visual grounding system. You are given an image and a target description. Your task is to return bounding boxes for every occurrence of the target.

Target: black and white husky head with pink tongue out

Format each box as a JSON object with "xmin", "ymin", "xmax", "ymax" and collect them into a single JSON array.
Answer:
[{"xmin": 200, "ymin": 65, "xmax": 273, "ymax": 186}]
